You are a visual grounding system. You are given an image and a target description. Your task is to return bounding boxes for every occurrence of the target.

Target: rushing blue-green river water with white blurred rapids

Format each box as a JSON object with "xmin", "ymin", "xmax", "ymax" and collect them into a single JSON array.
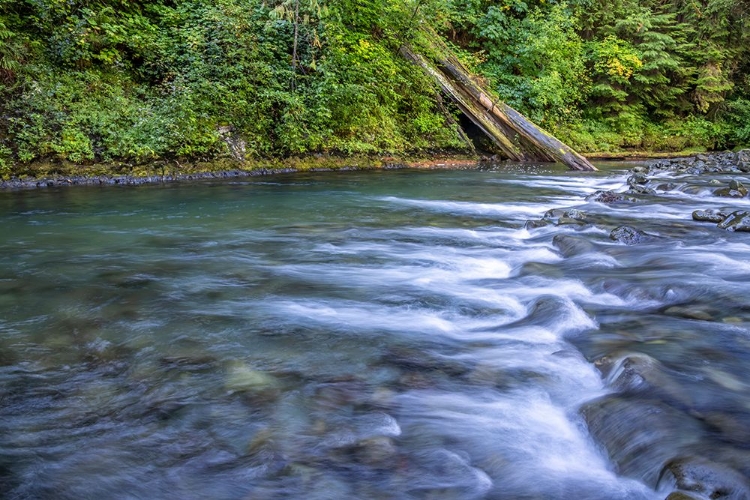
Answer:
[{"xmin": 0, "ymin": 164, "xmax": 750, "ymax": 500}]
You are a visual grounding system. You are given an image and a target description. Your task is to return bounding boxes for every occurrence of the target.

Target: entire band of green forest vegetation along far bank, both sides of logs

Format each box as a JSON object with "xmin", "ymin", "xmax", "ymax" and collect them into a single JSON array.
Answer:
[{"xmin": 0, "ymin": 0, "xmax": 750, "ymax": 170}]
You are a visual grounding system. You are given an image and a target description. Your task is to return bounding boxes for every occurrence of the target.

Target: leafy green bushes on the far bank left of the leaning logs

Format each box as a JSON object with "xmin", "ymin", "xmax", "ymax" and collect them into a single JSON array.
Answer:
[{"xmin": 0, "ymin": 0, "xmax": 461, "ymax": 163}]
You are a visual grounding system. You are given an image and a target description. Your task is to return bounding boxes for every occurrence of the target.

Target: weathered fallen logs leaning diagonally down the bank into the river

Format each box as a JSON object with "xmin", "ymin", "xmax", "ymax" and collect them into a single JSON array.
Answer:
[{"xmin": 401, "ymin": 40, "xmax": 596, "ymax": 170}]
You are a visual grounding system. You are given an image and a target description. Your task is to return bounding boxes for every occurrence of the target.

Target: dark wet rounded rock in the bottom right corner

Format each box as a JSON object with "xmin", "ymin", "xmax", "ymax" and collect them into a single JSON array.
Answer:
[{"xmin": 658, "ymin": 457, "xmax": 750, "ymax": 500}]
